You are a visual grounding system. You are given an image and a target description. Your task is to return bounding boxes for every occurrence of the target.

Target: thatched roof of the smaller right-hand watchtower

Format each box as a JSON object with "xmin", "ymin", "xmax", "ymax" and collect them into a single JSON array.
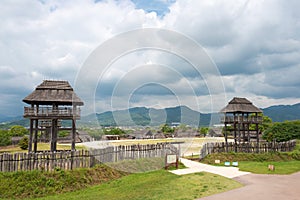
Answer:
[{"xmin": 220, "ymin": 97, "xmax": 262, "ymax": 113}]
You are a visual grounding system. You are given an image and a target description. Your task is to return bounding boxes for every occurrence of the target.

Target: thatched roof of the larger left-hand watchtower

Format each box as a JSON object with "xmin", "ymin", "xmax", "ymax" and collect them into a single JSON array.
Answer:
[{"xmin": 23, "ymin": 80, "xmax": 83, "ymax": 106}]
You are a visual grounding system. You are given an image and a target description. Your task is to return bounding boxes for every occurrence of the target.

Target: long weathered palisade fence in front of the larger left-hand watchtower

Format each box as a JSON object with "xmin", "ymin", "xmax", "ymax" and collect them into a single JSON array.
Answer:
[{"xmin": 0, "ymin": 143, "xmax": 178, "ymax": 172}]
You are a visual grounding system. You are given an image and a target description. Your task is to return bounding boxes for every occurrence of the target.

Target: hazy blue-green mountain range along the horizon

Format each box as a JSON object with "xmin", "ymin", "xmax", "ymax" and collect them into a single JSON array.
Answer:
[{"xmin": 0, "ymin": 103, "xmax": 300, "ymax": 128}]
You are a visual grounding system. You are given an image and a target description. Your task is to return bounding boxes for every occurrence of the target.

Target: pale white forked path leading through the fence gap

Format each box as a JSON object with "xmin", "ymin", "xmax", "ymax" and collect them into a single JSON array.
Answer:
[{"xmin": 171, "ymin": 158, "xmax": 250, "ymax": 178}]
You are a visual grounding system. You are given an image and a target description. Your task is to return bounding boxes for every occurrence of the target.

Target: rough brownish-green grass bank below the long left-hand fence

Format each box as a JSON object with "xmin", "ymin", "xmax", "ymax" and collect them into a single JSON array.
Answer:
[{"xmin": 0, "ymin": 165, "xmax": 127, "ymax": 199}]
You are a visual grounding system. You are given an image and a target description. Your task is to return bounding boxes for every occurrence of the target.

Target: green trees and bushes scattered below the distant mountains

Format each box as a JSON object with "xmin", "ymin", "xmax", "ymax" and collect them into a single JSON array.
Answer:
[{"xmin": 0, "ymin": 115, "xmax": 300, "ymax": 148}]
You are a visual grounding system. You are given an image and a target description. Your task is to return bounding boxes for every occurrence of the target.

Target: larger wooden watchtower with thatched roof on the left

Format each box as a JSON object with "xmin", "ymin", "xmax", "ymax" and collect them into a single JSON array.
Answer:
[{"xmin": 23, "ymin": 80, "xmax": 83, "ymax": 152}]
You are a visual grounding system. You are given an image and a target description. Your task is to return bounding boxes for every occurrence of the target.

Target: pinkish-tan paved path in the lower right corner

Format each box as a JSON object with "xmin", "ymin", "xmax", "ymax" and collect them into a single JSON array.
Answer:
[{"xmin": 201, "ymin": 172, "xmax": 300, "ymax": 200}]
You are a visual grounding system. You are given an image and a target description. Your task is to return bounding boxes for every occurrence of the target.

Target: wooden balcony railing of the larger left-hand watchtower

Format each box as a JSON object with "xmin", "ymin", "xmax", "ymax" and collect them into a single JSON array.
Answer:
[{"xmin": 24, "ymin": 107, "xmax": 80, "ymax": 118}]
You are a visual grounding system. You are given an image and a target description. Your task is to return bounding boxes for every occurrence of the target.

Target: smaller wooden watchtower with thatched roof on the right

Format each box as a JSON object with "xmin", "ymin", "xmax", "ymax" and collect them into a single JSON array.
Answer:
[{"xmin": 220, "ymin": 97, "xmax": 262, "ymax": 151}]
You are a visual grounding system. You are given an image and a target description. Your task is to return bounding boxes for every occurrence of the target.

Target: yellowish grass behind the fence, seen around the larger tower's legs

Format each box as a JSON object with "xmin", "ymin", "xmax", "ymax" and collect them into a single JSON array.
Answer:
[{"xmin": 0, "ymin": 143, "xmax": 85, "ymax": 153}]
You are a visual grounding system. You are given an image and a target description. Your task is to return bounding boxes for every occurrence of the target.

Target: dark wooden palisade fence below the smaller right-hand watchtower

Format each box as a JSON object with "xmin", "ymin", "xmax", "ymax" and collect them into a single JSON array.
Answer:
[{"xmin": 200, "ymin": 140, "xmax": 296, "ymax": 159}]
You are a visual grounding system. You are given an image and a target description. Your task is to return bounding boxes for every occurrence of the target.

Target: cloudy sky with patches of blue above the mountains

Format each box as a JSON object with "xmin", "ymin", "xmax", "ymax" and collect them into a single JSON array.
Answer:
[{"xmin": 0, "ymin": 0, "xmax": 300, "ymax": 116}]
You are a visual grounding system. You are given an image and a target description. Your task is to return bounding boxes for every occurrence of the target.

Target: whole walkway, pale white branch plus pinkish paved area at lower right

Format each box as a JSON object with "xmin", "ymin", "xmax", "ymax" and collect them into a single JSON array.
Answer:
[{"xmin": 171, "ymin": 158, "xmax": 300, "ymax": 200}]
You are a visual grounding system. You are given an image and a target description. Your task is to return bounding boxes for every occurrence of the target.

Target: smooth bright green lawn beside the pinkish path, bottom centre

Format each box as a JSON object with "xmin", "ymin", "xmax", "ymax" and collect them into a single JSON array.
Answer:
[{"xmin": 32, "ymin": 170, "xmax": 242, "ymax": 200}]
